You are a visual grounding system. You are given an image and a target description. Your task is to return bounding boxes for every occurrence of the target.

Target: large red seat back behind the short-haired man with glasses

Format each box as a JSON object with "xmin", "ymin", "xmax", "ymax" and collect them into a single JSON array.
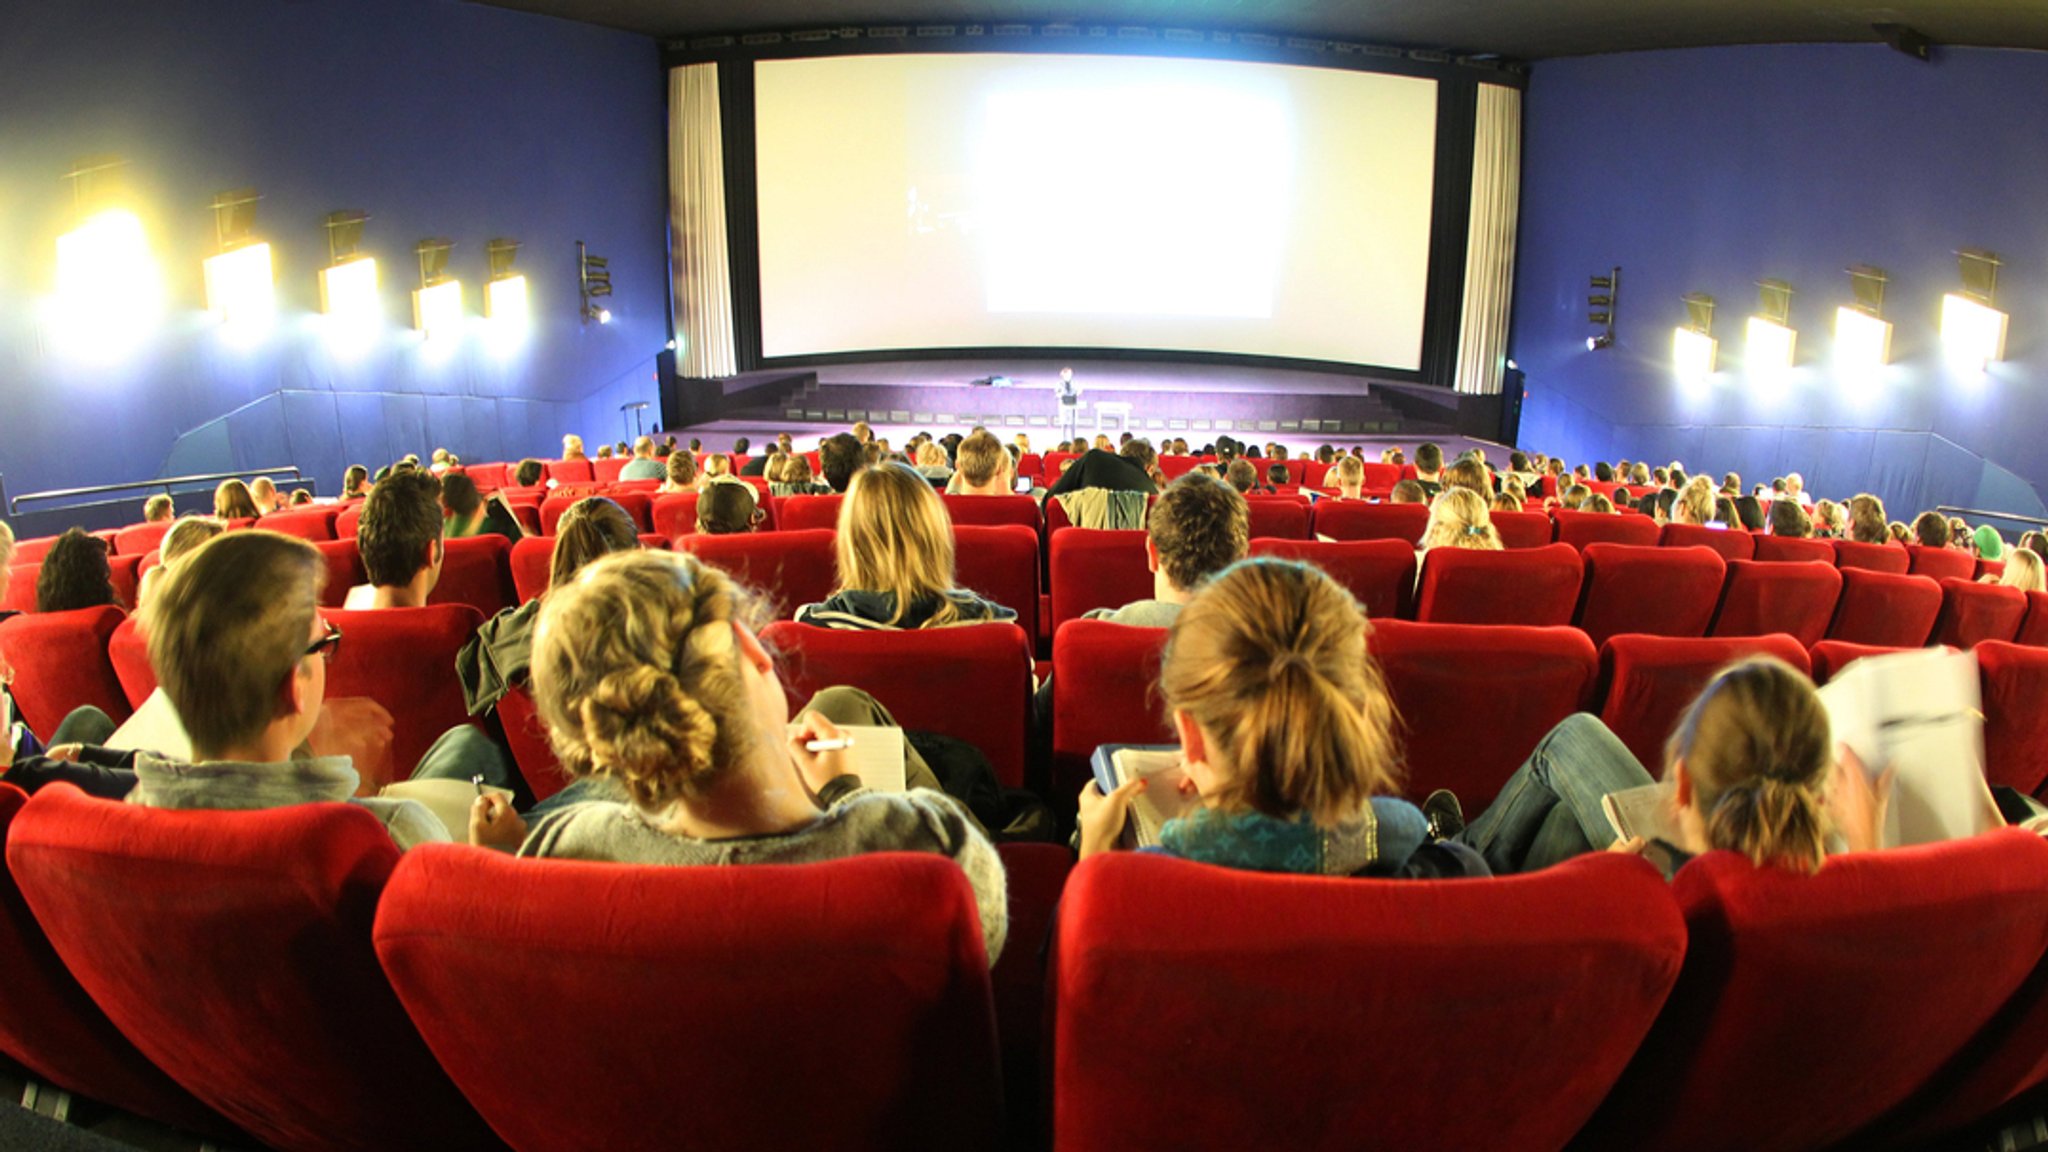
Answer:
[{"xmin": 6, "ymin": 785, "xmax": 503, "ymax": 1152}]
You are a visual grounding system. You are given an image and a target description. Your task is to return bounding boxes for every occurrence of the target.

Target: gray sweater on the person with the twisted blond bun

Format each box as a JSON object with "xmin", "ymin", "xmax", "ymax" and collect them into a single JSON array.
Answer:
[{"xmin": 518, "ymin": 789, "xmax": 1010, "ymax": 965}]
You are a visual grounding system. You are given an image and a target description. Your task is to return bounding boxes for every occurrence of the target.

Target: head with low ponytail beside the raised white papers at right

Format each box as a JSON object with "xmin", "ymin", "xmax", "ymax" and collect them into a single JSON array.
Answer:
[{"xmin": 1665, "ymin": 656, "xmax": 1835, "ymax": 871}]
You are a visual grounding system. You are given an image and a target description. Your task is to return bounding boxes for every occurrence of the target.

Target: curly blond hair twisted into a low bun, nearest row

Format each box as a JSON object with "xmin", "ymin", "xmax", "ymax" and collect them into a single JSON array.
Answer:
[{"xmin": 532, "ymin": 551, "xmax": 770, "ymax": 814}]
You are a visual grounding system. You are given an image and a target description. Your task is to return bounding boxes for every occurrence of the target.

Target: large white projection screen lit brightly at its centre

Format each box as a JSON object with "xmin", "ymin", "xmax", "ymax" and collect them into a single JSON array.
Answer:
[{"xmin": 754, "ymin": 53, "xmax": 1436, "ymax": 371}]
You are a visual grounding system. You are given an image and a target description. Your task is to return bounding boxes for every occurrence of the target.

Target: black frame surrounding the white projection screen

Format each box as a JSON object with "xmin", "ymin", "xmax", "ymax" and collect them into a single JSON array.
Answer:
[{"xmin": 664, "ymin": 25, "xmax": 1528, "ymax": 389}]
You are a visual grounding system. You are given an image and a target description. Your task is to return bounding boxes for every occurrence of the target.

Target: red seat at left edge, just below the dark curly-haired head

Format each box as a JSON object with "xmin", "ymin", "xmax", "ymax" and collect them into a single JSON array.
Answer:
[{"xmin": 0, "ymin": 605, "xmax": 133, "ymax": 740}]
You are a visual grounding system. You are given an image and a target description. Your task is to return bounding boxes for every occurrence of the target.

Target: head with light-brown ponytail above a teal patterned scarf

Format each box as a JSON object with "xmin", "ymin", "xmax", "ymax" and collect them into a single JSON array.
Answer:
[{"xmin": 1159, "ymin": 558, "xmax": 1399, "ymax": 828}]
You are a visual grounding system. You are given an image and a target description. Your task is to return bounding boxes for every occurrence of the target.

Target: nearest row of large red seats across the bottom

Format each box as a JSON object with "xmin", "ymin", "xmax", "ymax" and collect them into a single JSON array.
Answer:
[{"xmin": 0, "ymin": 770, "xmax": 2048, "ymax": 1152}]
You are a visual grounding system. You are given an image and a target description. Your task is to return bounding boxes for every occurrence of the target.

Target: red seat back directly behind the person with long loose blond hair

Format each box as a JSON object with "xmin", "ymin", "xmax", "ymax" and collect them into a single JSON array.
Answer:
[{"xmin": 761, "ymin": 619, "xmax": 1032, "ymax": 787}]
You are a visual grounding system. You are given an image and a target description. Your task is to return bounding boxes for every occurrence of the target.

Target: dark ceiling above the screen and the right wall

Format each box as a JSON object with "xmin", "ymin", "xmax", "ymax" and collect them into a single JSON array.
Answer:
[{"xmin": 471, "ymin": 0, "xmax": 2048, "ymax": 59}]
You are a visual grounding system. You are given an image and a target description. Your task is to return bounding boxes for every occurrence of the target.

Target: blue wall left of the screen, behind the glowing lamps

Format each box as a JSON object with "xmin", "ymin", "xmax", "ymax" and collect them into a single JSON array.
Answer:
[{"xmin": 0, "ymin": 0, "xmax": 668, "ymax": 516}]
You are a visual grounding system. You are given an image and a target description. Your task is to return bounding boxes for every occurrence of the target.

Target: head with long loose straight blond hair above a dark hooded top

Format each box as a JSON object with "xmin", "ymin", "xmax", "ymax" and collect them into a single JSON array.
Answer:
[{"xmin": 838, "ymin": 463, "xmax": 961, "ymax": 627}]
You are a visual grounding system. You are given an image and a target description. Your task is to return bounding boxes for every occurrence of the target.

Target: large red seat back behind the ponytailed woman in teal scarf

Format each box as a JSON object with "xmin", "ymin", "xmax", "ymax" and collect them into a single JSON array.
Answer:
[{"xmin": 1053, "ymin": 849, "xmax": 1687, "ymax": 1152}]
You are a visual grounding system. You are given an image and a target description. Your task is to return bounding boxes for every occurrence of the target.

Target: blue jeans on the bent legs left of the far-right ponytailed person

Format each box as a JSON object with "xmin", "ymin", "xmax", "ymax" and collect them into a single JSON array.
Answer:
[{"xmin": 1458, "ymin": 711, "xmax": 1655, "ymax": 875}]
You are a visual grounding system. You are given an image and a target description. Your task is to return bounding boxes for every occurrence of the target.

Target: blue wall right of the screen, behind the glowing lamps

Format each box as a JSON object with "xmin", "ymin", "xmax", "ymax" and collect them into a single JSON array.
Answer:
[{"xmin": 1511, "ymin": 45, "xmax": 2048, "ymax": 519}]
